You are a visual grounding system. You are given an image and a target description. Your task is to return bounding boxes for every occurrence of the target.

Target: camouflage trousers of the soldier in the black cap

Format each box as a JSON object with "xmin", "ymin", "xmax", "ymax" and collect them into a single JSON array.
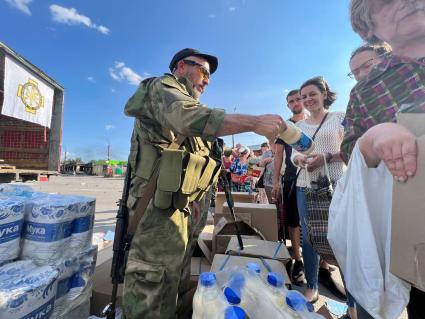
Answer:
[{"xmin": 123, "ymin": 191, "xmax": 211, "ymax": 319}]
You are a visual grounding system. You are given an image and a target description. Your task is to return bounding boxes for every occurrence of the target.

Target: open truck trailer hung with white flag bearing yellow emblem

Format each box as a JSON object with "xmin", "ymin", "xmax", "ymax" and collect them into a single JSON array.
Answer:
[{"xmin": 0, "ymin": 42, "xmax": 64, "ymax": 182}]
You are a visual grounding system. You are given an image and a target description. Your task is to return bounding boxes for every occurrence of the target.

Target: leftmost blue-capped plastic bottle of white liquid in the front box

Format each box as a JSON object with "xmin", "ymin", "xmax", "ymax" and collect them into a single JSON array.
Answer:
[{"xmin": 192, "ymin": 272, "xmax": 228, "ymax": 319}]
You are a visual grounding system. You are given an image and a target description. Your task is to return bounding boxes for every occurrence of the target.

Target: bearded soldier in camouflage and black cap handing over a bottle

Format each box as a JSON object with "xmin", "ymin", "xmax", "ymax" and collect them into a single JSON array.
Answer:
[{"xmin": 123, "ymin": 49, "xmax": 286, "ymax": 319}]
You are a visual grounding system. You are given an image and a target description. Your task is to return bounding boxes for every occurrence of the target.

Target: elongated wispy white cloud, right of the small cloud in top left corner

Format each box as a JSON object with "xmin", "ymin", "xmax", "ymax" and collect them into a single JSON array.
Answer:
[{"xmin": 50, "ymin": 4, "xmax": 109, "ymax": 34}]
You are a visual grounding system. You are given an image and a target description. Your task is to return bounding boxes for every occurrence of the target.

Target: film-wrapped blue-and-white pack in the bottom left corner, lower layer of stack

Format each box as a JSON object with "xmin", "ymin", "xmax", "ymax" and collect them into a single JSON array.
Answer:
[{"xmin": 0, "ymin": 260, "xmax": 58, "ymax": 319}]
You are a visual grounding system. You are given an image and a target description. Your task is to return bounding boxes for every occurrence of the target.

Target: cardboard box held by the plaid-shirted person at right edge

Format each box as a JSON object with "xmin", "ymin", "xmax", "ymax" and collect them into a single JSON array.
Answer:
[{"xmin": 390, "ymin": 113, "xmax": 425, "ymax": 291}]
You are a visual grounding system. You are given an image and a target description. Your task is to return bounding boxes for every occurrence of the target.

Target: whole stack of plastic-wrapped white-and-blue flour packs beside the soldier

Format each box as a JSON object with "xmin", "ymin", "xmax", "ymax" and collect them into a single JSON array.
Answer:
[{"xmin": 0, "ymin": 191, "xmax": 97, "ymax": 319}]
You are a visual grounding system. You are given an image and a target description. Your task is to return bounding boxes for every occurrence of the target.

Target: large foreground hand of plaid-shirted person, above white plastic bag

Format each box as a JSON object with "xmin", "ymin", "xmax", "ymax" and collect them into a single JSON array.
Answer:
[{"xmin": 359, "ymin": 123, "xmax": 417, "ymax": 182}]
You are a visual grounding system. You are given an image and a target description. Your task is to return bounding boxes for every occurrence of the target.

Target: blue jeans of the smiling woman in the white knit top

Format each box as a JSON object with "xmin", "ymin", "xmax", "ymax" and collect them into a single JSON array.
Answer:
[{"xmin": 297, "ymin": 187, "xmax": 320, "ymax": 289}]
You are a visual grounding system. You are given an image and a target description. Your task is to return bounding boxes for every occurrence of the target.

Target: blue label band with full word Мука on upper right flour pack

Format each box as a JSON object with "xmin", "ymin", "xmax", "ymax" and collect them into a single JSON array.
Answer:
[{"xmin": 23, "ymin": 221, "xmax": 72, "ymax": 242}]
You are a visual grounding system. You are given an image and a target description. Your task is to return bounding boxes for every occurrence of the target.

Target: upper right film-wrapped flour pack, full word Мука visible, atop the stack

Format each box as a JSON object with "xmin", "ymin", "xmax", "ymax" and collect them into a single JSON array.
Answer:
[{"xmin": 21, "ymin": 195, "xmax": 95, "ymax": 265}]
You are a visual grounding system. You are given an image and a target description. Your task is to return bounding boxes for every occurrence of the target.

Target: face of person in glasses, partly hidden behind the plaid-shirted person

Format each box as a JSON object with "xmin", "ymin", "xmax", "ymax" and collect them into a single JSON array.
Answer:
[{"xmin": 348, "ymin": 43, "xmax": 391, "ymax": 81}]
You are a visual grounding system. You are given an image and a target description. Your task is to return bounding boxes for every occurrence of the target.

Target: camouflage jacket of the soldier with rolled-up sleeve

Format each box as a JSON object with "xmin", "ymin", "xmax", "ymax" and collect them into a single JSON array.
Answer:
[{"xmin": 124, "ymin": 74, "xmax": 225, "ymax": 206}]
